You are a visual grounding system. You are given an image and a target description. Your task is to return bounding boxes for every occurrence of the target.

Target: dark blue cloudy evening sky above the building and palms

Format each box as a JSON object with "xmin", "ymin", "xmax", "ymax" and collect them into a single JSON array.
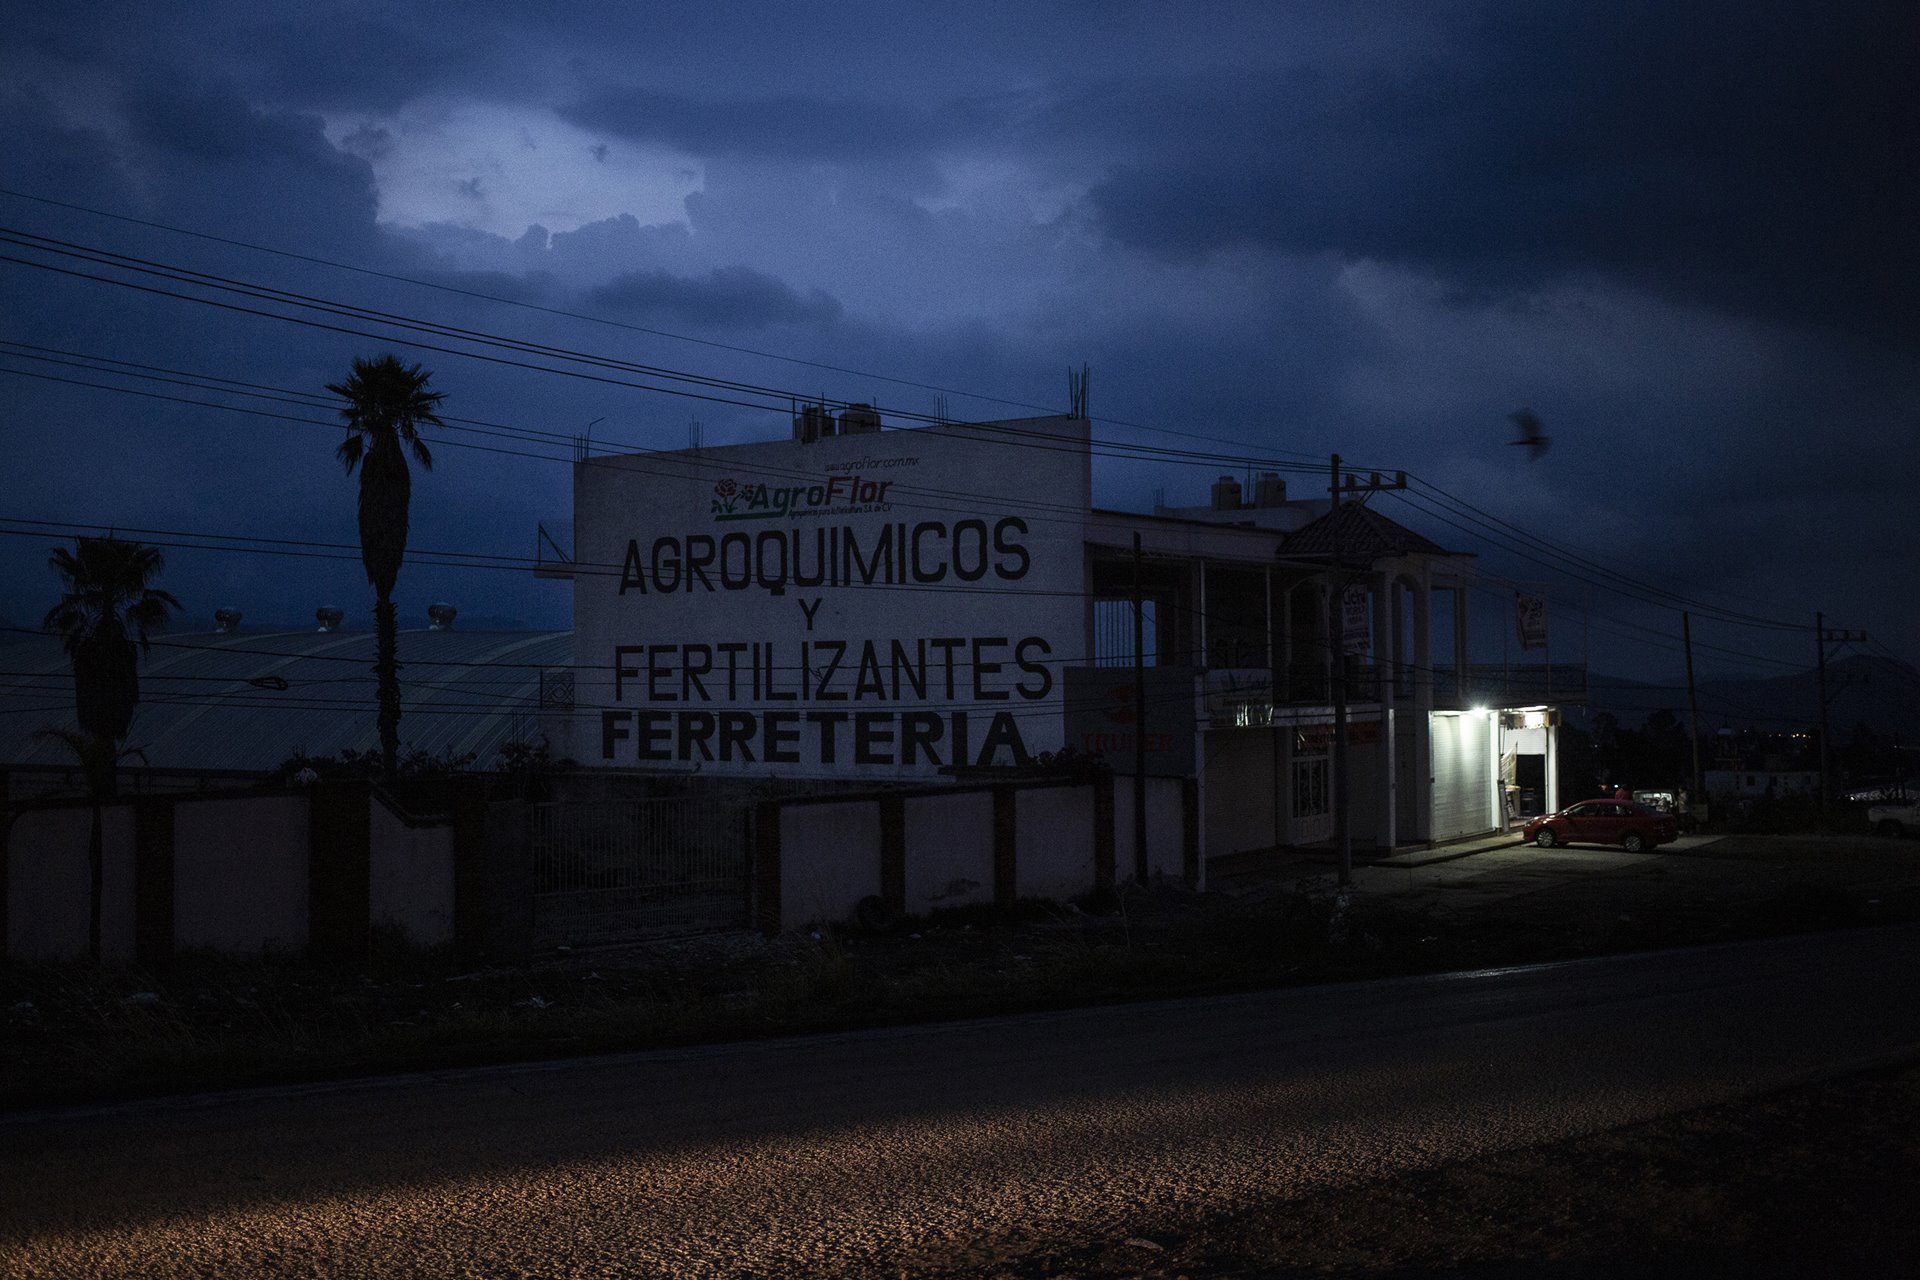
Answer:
[{"xmin": 0, "ymin": 0, "xmax": 1920, "ymax": 702}]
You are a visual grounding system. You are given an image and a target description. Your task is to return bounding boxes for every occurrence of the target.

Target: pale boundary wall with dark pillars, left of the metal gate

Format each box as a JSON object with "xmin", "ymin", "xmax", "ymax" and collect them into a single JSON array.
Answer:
[{"xmin": 0, "ymin": 783, "xmax": 483, "ymax": 965}]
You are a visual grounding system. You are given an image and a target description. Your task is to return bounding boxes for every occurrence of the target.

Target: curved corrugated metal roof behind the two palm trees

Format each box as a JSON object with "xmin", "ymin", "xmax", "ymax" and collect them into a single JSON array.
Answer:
[{"xmin": 0, "ymin": 629, "xmax": 572, "ymax": 770}]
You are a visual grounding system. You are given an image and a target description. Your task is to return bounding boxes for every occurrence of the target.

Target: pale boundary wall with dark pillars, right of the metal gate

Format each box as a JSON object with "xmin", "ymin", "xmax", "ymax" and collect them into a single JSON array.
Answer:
[{"xmin": 755, "ymin": 775, "xmax": 1204, "ymax": 933}]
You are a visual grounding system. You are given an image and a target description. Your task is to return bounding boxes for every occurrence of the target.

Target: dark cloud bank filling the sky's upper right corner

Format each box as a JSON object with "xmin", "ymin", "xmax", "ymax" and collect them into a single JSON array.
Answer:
[{"xmin": 1091, "ymin": 4, "xmax": 1920, "ymax": 338}]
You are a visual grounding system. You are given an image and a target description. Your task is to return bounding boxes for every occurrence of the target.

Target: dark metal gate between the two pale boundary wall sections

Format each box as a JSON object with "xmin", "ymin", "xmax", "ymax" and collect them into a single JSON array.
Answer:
[{"xmin": 528, "ymin": 796, "xmax": 753, "ymax": 946}]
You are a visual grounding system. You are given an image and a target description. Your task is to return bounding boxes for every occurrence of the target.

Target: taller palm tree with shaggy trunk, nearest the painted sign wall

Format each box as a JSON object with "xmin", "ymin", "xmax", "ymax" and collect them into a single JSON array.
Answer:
[{"xmin": 326, "ymin": 355, "xmax": 444, "ymax": 777}]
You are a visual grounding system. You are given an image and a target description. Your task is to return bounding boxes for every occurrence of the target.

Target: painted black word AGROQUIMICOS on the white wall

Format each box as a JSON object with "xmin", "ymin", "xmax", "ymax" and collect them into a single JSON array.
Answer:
[{"xmin": 618, "ymin": 516, "xmax": 1033, "ymax": 595}]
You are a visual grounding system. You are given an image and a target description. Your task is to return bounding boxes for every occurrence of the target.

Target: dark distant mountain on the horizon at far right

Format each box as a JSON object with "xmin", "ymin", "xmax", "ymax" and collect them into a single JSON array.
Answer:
[{"xmin": 1586, "ymin": 654, "xmax": 1920, "ymax": 743}]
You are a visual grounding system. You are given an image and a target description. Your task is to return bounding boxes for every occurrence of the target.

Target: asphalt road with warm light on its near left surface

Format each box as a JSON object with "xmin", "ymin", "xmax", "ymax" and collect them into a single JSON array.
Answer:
[{"xmin": 11, "ymin": 927, "xmax": 1920, "ymax": 1280}]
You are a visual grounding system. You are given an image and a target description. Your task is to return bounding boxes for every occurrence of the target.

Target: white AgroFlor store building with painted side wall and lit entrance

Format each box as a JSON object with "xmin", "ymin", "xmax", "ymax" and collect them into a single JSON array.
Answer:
[{"xmin": 545, "ymin": 416, "xmax": 1584, "ymax": 856}]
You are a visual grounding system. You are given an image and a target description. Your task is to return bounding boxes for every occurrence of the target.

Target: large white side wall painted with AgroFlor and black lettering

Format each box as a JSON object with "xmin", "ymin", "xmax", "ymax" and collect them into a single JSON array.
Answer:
[{"xmin": 572, "ymin": 418, "xmax": 1091, "ymax": 777}]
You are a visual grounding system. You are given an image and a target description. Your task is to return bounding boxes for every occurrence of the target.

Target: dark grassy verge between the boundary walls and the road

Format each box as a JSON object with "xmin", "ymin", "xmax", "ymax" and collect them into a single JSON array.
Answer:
[{"xmin": 0, "ymin": 852, "xmax": 1920, "ymax": 1107}]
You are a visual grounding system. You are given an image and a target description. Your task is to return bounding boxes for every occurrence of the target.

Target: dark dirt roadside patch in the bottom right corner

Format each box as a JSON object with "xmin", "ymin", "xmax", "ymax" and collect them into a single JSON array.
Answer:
[{"xmin": 929, "ymin": 1067, "xmax": 1920, "ymax": 1280}]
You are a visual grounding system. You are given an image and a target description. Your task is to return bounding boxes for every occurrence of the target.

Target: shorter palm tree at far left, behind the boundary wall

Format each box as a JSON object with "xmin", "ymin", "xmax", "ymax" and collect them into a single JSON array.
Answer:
[{"xmin": 40, "ymin": 535, "xmax": 180, "ymax": 961}]
